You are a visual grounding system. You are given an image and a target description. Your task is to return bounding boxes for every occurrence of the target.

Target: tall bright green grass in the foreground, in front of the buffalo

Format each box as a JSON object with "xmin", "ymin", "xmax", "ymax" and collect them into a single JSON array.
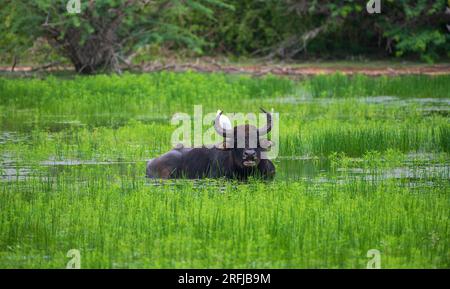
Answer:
[{"xmin": 0, "ymin": 169, "xmax": 450, "ymax": 268}]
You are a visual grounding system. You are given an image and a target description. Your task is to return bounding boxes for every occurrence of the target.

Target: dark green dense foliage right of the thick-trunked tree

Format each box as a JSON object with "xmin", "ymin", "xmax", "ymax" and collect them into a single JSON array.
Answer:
[{"xmin": 191, "ymin": 0, "xmax": 450, "ymax": 61}]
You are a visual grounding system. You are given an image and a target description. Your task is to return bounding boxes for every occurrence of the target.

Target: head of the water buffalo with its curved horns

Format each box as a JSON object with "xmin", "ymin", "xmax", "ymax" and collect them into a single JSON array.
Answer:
[{"xmin": 214, "ymin": 108, "xmax": 272, "ymax": 168}]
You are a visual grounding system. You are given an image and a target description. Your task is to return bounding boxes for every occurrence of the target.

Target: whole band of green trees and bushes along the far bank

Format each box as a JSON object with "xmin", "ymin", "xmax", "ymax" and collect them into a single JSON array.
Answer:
[{"xmin": 0, "ymin": 0, "xmax": 450, "ymax": 73}]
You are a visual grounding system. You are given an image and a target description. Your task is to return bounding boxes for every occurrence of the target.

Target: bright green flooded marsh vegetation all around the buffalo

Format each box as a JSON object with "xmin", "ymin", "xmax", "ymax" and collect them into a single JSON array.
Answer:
[{"xmin": 0, "ymin": 72, "xmax": 450, "ymax": 268}]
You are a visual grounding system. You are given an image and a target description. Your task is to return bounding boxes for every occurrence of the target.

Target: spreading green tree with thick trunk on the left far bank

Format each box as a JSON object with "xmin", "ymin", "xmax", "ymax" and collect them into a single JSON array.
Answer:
[{"xmin": 0, "ymin": 0, "xmax": 230, "ymax": 74}]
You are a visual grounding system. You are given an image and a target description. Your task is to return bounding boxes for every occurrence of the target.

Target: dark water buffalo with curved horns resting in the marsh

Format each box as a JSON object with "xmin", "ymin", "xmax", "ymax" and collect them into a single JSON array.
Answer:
[{"xmin": 147, "ymin": 109, "xmax": 275, "ymax": 180}]
